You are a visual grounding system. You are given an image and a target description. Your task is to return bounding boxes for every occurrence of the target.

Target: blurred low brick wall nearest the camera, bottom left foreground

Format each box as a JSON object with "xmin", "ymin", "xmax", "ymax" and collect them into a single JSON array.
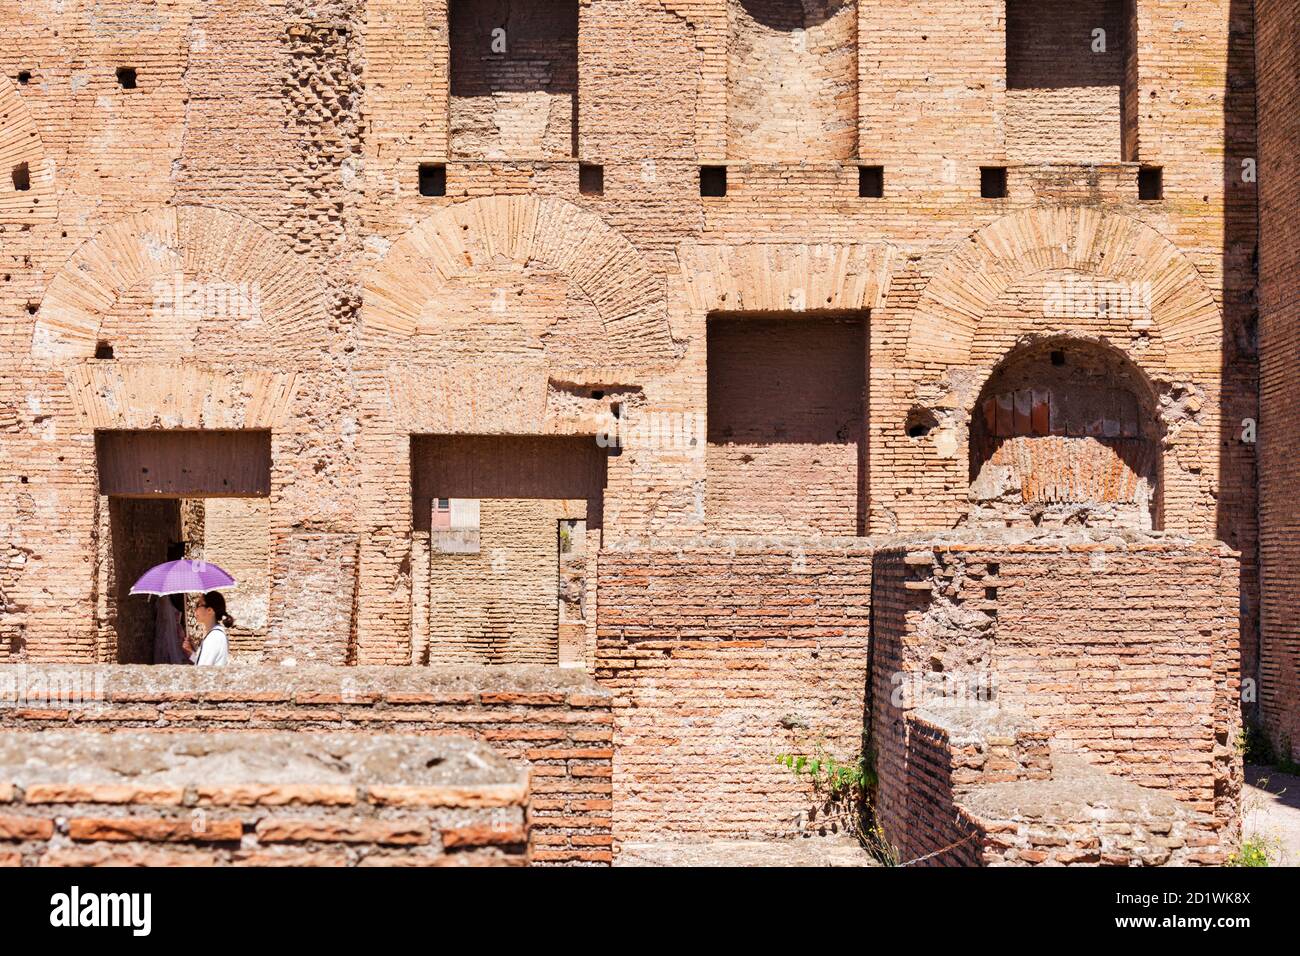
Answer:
[{"xmin": 0, "ymin": 730, "xmax": 528, "ymax": 866}]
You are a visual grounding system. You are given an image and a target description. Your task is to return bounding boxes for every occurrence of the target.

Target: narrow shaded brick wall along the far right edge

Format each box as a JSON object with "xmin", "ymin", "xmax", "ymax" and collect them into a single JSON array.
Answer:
[{"xmin": 1256, "ymin": 0, "xmax": 1300, "ymax": 757}]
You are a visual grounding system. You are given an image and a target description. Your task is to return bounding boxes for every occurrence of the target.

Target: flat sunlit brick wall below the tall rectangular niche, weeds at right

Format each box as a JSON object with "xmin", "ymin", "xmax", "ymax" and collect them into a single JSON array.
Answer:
[{"xmin": 597, "ymin": 538, "xmax": 871, "ymax": 842}]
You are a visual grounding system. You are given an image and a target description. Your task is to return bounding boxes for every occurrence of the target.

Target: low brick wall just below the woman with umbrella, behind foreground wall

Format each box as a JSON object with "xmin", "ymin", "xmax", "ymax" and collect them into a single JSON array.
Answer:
[{"xmin": 0, "ymin": 665, "xmax": 614, "ymax": 865}]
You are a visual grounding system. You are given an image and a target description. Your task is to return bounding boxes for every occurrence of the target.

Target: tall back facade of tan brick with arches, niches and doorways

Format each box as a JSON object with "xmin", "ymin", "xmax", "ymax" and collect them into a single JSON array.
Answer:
[{"xmin": 0, "ymin": 0, "xmax": 1268, "ymax": 663}]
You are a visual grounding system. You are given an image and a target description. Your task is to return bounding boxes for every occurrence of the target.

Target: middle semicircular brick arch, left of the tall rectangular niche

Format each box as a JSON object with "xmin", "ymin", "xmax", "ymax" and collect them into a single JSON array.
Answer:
[{"xmin": 361, "ymin": 196, "xmax": 675, "ymax": 363}]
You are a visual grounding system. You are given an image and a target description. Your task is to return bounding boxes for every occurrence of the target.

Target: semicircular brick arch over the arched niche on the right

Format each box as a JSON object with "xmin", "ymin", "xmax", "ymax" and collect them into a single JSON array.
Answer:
[{"xmin": 907, "ymin": 207, "xmax": 1222, "ymax": 373}]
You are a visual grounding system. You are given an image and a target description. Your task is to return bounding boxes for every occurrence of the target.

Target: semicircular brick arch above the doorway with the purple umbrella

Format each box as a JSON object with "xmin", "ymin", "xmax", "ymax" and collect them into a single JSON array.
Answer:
[{"xmin": 31, "ymin": 206, "xmax": 328, "ymax": 362}]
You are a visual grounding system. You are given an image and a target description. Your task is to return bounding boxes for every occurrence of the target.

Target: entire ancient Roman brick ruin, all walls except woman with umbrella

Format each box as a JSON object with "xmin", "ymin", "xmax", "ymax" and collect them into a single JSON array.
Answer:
[{"xmin": 0, "ymin": 0, "xmax": 1300, "ymax": 865}]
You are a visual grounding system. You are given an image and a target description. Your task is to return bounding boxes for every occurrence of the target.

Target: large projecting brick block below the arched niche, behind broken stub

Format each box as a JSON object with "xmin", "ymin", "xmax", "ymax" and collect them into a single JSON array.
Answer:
[{"xmin": 871, "ymin": 532, "xmax": 1240, "ymax": 862}]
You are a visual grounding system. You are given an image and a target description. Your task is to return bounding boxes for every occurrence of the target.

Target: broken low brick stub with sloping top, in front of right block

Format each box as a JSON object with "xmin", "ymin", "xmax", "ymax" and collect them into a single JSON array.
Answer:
[{"xmin": 883, "ymin": 701, "xmax": 1229, "ymax": 866}]
